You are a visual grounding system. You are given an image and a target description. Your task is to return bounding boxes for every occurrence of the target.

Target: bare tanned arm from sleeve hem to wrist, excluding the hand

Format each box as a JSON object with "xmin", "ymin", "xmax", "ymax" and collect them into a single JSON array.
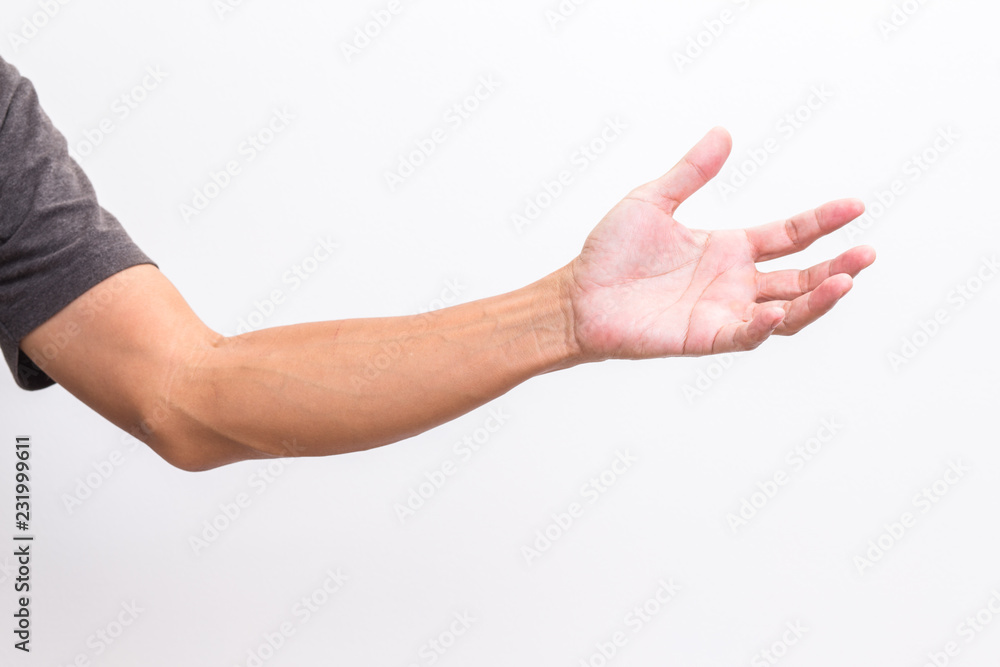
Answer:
[{"xmin": 22, "ymin": 265, "xmax": 575, "ymax": 470}]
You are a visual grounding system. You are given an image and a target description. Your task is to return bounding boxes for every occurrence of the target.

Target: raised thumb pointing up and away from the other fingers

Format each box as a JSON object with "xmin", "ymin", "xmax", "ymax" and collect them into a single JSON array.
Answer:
[{"xmin": 637, "ymin": 127, "xmax": 733, "ymax": 213}]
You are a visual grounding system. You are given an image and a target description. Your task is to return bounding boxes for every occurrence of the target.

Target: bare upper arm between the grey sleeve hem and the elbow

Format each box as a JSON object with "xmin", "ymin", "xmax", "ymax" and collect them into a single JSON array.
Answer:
[{"xmin": 21, "ymin": 264, "xmax": 247, "ymax": 470}]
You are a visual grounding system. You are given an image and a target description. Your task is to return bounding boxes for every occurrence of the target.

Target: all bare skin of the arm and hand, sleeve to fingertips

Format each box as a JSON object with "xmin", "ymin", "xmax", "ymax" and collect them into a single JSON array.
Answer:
[{"xmin": 21, "ymin": 128, "xmax": 875, "ymax": 471}]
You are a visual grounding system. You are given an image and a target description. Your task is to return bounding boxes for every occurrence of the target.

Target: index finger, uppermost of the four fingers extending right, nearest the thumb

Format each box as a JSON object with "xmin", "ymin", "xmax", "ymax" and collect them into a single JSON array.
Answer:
[{"xmin": 744, "ymin": 199, "xmax": 865, "ymax": 262}]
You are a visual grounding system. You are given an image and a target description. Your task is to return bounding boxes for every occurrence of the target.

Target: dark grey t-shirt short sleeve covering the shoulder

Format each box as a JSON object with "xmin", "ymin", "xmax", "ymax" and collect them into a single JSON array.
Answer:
[{"xmin": 0, "ymin": 59, "xmax": 155, "ymax": 389}]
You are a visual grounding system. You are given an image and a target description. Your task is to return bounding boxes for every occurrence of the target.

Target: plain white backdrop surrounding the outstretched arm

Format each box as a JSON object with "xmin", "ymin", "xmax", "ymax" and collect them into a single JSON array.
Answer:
[{"xmin": 0, "ymin": 0, "xmax": 1000, "ymax": 667}]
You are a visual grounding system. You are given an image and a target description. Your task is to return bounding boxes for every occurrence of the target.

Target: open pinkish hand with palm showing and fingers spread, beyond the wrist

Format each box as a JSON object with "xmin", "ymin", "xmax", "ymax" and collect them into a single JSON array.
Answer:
[{"xmin": 565, "ymin": 128, "xmax": 875, "ymax": 360}]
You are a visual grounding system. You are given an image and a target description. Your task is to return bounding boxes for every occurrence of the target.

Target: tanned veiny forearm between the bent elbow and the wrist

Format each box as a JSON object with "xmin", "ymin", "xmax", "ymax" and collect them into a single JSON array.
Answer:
[{"xmin": 162, "ymin": 272, "xmax": 576, "ymax": 462}]
